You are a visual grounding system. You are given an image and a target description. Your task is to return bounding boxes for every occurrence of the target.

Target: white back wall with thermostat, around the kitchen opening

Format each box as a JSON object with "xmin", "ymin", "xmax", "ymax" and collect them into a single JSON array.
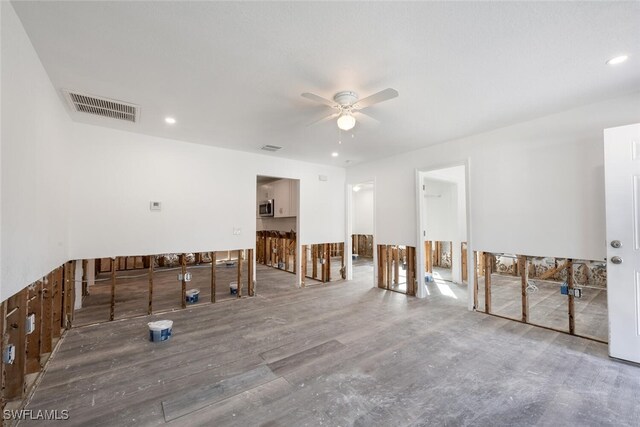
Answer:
[{"xmin": 69, "ymin": 123, "xmax": 345, "ymax": 259}]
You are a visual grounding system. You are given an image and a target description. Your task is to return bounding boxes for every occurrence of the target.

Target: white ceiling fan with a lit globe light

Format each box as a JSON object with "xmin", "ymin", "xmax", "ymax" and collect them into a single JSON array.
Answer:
[{"xmin": 302, "ymin": 88, "xmax": 398, "ymax": 130}]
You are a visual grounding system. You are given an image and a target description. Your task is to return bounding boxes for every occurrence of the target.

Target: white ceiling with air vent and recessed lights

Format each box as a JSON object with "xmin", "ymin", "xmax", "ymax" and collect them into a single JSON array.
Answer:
[{"xmin": 13, "ymin": 1, "xmax": 640, "ymax": 165}]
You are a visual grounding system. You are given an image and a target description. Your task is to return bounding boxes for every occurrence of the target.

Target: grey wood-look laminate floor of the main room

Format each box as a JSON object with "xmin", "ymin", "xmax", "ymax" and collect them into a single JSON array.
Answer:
[{"xmin": 20, "ymin": 265, "xmax": 640, "ymax": 426}]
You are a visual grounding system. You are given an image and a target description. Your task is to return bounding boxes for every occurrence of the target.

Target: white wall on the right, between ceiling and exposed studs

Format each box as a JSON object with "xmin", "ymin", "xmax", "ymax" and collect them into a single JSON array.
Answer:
[{"xmin": 348, "ymin": 92, "xmax": 640, "ymax": 259}]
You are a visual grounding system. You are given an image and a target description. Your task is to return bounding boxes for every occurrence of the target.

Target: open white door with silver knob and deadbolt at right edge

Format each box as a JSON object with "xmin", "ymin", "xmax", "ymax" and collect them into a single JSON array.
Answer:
[{"xmin": 604, "ymin": 124, "xmax": 640, "ymax": 363}]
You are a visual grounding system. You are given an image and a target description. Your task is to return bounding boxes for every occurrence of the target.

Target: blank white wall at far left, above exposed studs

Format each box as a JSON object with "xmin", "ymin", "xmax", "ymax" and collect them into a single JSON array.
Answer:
[{"xmin": 0, "ymin": 5, "xmax": 71, "ymax": 301}]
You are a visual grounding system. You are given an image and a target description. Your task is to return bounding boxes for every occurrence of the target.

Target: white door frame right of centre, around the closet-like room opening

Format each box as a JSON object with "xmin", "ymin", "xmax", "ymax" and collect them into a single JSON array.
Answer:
[{"xmin": 415, "ymin": 157, "xmax": 476, "ymax": 311}]
